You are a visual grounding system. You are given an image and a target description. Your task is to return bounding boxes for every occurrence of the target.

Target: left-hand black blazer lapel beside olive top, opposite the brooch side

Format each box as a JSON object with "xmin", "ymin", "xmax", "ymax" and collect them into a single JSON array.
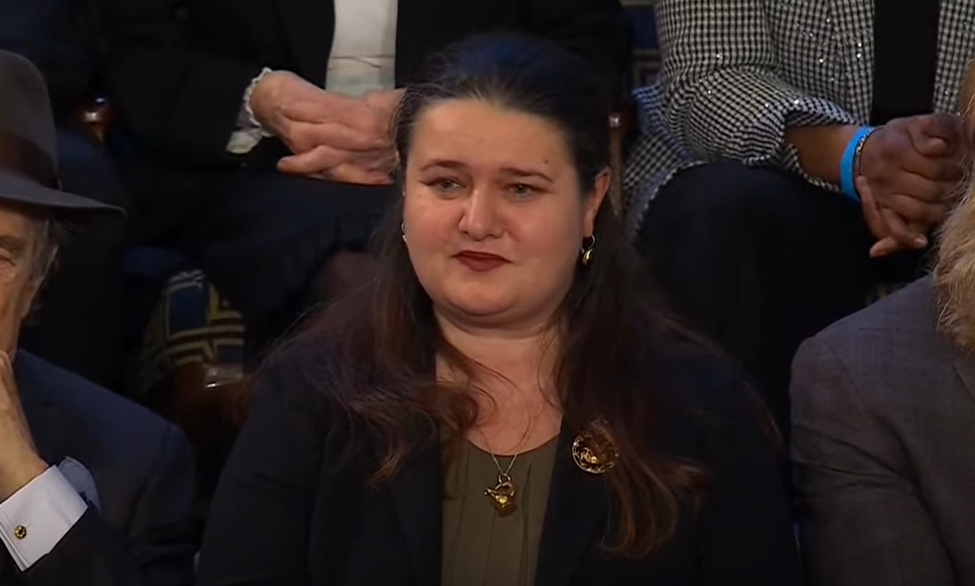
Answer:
[{"xmin": 389, "ymin": 434, "xmax": 443, "ymax": 584}]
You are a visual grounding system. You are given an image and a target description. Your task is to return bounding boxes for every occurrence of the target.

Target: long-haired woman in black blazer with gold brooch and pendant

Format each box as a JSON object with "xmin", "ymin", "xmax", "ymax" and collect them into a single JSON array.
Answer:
[{"xmin": 199, "ymin": 37, "xmax": 799, "ymax": 586}]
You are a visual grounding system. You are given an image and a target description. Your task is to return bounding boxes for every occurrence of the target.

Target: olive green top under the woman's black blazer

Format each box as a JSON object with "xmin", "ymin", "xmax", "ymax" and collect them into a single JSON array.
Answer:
[{"xmin": 442, "ymin": 439, "xmax": 556, "ymax": 586}]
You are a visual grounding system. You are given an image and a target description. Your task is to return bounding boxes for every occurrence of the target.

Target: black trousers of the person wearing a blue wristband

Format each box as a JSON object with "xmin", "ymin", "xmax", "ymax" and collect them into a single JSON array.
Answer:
[{"xmin": 638, "ymin": 161, "xmax": 921, "ymax": 436}]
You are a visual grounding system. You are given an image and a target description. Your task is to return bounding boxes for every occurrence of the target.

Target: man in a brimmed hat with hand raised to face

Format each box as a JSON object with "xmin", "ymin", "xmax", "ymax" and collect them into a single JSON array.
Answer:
[{"xmin": 0, "ymin": 51, "xmax": 196, "ymax": 586}]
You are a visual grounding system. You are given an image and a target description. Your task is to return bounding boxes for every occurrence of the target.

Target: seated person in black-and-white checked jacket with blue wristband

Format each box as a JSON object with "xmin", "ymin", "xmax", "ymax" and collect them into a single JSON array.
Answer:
[{"xmin": 627, "ymin": 0, "xmax": 975, "ymax": 431}]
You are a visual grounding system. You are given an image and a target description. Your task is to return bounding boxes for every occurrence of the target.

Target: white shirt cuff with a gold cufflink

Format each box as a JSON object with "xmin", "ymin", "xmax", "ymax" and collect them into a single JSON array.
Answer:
[{"xmin": 0, "ymin": 466, "xmax": 88, "ymax": 572}]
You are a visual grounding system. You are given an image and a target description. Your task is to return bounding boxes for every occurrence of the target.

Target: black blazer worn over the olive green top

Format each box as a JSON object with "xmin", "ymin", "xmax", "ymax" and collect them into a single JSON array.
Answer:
[{"xmin": 198, "ymin": 340, "xmax": 800, "ymax": 586}]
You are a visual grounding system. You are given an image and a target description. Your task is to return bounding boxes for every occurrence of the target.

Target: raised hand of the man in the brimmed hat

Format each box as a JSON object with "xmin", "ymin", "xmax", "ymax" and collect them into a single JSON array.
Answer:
[{"xmin": 0, "ymin": 352, "xmax": 48, "ymax": 502}]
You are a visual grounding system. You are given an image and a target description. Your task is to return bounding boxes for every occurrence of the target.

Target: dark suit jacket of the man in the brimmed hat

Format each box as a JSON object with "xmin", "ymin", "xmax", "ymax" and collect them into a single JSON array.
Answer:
[{"xmin": 0, "ymin": 352, "xmax": 196, "ymax": 586}]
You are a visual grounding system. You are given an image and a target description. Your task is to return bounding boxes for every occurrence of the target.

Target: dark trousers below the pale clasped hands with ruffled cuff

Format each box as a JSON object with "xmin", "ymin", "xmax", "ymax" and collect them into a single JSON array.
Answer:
[{"xmin": 119, "ymin": 155, "xmax": 398, "ymax": 363}]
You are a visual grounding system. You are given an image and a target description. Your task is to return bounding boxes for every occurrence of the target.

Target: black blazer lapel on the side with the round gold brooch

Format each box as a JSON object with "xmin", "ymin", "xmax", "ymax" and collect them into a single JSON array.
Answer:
[{"xmin": 535, "ymin": 425, "xmax": 609, "ymax": 586}]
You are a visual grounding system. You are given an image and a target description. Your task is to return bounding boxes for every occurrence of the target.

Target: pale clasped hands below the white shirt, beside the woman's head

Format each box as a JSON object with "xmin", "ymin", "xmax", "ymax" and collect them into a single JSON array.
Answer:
[{"xmin": 251, "ymin": 72, "xmax": 402, "ymax": 185}]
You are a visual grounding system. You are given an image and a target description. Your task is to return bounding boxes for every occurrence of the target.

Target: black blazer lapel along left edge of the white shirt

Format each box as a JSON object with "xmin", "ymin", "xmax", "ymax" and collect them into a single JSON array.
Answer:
[{"xmin": 274, "ymin": 0, "xmax": 335, "ymax": 85}]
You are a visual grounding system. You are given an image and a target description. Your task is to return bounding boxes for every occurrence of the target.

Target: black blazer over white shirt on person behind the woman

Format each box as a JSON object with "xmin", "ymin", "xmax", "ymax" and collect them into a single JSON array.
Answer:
[{"xmin": 97, "ymin": 0, "xmax": 631, "ymax": 162}]
